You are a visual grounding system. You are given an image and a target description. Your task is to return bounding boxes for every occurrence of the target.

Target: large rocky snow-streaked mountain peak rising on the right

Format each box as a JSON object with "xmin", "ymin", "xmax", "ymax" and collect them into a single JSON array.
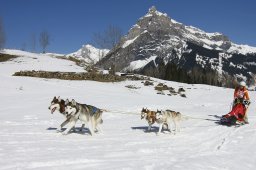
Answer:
[{"xmin": 98, "ymin": 7, "xmax": 256, "ymax": 84}]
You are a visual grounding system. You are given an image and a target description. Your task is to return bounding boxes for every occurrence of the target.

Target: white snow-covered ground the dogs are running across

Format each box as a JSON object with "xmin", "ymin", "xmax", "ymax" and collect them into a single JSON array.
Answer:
[{"xmin": 0, "ymin": 49, "xmax": 256, "ymax": 170}]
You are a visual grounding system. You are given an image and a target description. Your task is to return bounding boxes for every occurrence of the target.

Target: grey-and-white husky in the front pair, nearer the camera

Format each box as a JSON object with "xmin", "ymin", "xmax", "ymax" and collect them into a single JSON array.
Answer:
[{"xmin": 63, "ymin": 99, "xmax": 104, "ymax": 135}]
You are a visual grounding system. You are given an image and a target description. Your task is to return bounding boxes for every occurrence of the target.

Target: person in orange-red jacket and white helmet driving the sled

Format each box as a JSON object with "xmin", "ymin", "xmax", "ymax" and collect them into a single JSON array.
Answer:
[{"xmin": 233, "ymin": 81, "xmax": 250, "ymax": 123}]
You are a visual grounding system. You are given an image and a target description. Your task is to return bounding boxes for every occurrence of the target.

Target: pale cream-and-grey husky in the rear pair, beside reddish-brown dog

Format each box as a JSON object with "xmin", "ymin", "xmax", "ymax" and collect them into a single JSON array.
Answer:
[{"xmin": 156, "ymin": 110, "xmax": 181, "ymax": 134}]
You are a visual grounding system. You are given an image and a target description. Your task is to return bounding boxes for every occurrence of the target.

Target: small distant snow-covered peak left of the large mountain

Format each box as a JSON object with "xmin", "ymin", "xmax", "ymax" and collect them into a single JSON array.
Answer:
[{"xmin": 66, "ymin": 44, "xmax": 109, "ymax": 65}]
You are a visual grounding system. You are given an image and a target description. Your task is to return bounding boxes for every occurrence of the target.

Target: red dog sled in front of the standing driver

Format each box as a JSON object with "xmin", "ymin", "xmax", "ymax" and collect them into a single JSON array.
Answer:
[{"xmin": 219, "ymin": 98, "xmax": 250, "ymax": 126}]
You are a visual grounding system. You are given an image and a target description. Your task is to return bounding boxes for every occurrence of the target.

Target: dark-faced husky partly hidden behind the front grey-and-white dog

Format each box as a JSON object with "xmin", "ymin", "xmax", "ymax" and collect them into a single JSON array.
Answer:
[{"xmin": 48, "ymin": 96, "xmax": 84, "ymax": 131}]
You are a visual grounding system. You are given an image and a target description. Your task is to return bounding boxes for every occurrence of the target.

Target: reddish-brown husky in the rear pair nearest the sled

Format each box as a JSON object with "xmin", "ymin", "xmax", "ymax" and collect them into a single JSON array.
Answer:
[{"xmin": 141, "ymin": 107, "xmax": 168, "ymax": 131}]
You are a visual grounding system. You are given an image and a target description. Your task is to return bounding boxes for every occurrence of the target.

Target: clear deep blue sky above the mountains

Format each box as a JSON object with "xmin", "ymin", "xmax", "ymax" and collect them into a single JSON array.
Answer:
[{"xmin": 0, "ymin": 0, "xmax": 256, "ymax": 54}]
